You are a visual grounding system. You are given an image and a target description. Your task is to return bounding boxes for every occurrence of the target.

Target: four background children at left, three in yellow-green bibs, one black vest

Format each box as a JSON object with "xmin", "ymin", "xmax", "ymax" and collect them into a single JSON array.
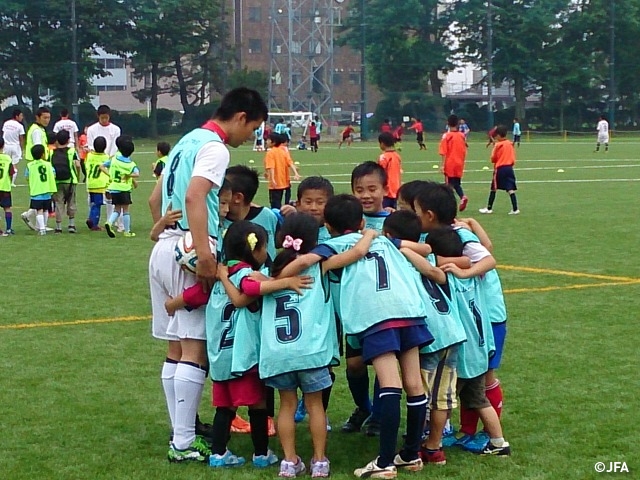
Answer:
[{"xmin": 15, "ymin": 130, "xmax": 140, "ymax": 238}]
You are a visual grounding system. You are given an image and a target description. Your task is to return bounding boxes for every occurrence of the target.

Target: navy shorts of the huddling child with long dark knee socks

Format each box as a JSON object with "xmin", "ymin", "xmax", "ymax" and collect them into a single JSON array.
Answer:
[{"xmin": 362, "ymin": 324, "xmax": 433, "ymax": 363}]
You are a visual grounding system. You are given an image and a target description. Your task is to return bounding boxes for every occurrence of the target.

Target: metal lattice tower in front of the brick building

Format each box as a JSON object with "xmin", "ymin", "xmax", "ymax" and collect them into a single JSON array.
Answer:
[{"xmin": 269, "ymin": 0, "xmax": 342, "ymax": 115}]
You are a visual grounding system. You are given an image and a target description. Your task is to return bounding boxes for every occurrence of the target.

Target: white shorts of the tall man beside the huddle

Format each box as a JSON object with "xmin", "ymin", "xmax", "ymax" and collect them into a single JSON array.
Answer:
[{"xmin": 149, "ymin": 235, "xmax": 206, "ymax": 341}]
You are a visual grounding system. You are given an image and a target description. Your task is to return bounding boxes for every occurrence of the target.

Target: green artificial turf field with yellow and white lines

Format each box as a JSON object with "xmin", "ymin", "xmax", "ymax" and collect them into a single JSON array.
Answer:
[{"xmin": 0, "ymin": 135, "xmax": 640, "ymax": 480}]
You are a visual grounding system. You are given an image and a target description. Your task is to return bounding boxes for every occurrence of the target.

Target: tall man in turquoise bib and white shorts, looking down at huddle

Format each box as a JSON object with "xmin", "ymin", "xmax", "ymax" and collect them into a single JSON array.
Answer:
[{"xmin": 149, "ymin": 88, "xmax": 267, "ymax": 462}]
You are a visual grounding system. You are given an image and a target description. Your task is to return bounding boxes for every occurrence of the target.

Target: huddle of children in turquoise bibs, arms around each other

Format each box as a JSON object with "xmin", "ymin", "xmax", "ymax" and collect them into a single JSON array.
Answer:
[{"xmin": 158, "ymin": 162, "xmax": 510, "ymax": 478}]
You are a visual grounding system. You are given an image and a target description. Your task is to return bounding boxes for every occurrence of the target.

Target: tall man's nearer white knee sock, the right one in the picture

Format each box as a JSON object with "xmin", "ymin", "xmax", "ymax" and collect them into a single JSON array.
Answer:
[{"xmin": 173, "ymin": 362, "xmax": 207, "ymax": 450}]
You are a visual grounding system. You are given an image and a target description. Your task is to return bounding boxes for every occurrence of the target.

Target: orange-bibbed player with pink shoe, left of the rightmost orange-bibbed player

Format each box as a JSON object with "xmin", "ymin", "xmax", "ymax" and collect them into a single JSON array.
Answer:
[{"xmin": 439, "ymin": 115, "xmax": 469, "ymax": 212}]
